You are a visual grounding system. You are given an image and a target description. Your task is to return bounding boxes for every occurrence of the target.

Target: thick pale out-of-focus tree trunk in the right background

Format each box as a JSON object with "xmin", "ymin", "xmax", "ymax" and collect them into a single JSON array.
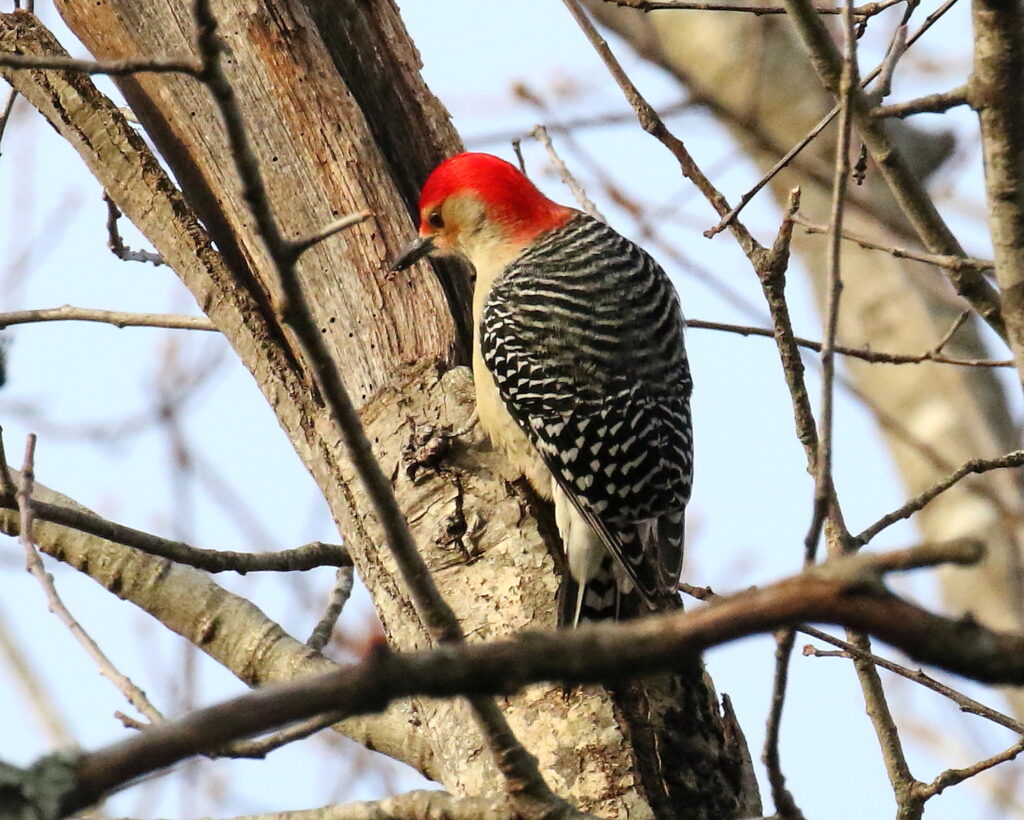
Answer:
[{"xmin": 588, "ymin": 0, "xmax": 1024, "ymax": 714}]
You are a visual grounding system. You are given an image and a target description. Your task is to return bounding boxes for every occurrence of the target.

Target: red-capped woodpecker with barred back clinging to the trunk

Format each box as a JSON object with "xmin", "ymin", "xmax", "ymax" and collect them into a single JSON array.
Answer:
[{"xmin": 394, "ymin": 154, "xmax": 693, "ymax": 624}]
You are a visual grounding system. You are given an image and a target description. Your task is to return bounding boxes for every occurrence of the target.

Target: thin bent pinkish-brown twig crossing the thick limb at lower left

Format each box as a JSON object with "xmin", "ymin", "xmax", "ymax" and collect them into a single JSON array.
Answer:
[{"xmin": 17, "ymin": 433, "xmax": 164, "ymax": 724}]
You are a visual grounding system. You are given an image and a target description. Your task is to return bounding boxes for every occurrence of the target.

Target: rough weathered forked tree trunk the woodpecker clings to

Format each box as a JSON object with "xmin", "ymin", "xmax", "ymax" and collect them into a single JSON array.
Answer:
[{"xmin": 0, "ymin": 0, "xmax": 759, "ymax": 818}]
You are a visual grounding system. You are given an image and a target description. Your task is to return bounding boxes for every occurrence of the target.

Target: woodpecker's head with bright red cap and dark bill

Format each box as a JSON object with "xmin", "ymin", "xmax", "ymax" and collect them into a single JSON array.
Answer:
[{"xmin": 392, "ymin": 154, "xmax": 574, "ymax": 270}]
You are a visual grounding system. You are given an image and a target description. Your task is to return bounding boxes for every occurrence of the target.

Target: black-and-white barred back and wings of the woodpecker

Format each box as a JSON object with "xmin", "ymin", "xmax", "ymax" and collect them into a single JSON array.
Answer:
[{"xmin": 480, "ymin": 214, "xmax": 693, "ymax": 621}]
